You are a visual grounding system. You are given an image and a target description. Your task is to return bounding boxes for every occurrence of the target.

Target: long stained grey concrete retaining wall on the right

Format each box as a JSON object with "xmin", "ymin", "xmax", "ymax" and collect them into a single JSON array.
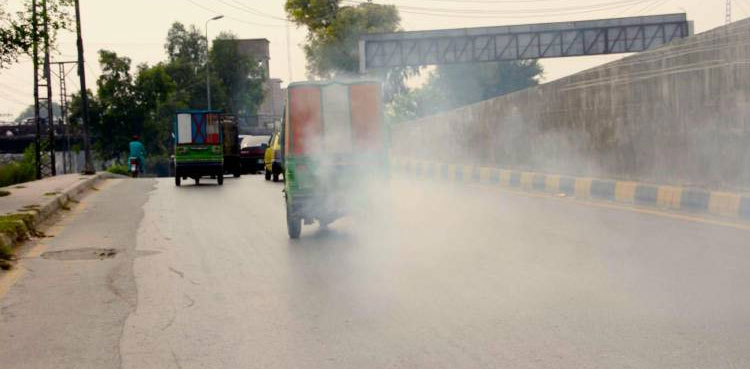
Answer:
[{"xmin": 392, "ymin": 20, "xmax": 750, "ymax": 190}]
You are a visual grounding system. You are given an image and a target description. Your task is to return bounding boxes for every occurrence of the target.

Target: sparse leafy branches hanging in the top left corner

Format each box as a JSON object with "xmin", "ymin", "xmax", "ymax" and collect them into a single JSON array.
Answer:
[{"xmin": 0, "ymin": 0, "xmax": 73, "ymax": 68}]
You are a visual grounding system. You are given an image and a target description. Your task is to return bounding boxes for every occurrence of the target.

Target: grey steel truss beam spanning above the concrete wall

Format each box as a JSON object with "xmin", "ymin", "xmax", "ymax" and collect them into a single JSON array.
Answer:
[{"xmin": 359, "ymin": 14, "xmax": 692, "ymax": 73}]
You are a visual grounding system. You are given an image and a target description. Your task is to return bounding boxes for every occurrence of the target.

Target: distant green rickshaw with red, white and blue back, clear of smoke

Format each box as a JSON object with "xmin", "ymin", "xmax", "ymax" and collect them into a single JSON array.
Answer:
[{"xmin": 173, "ymin": 110, "xmax": 224, "ymax": 186}]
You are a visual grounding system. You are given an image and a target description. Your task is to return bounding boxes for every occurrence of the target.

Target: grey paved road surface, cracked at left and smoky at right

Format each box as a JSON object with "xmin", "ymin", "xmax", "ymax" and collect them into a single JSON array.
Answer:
[{"xmin": 0, "ymin": 176, "xmax": 750, "ymax": 368}]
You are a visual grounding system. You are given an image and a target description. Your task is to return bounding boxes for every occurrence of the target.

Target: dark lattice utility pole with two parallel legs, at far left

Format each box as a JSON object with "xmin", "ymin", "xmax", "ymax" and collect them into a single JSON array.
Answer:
[{"xmin": 31, "ymin": 0, "xmax": 56, "ymax": 179}]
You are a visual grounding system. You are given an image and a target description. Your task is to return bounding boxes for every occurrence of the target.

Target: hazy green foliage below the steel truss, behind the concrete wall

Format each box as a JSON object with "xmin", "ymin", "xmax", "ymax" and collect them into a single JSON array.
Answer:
[{"xmin": 387, "ymin": 60, "xmax": 544, "ymax": 122}]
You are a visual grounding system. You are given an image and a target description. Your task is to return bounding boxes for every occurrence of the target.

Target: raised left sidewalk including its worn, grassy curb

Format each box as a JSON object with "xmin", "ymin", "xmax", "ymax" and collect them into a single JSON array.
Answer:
[{"xmin": 0, "ymin": 173, "xmax": 111, "ymax": 258}]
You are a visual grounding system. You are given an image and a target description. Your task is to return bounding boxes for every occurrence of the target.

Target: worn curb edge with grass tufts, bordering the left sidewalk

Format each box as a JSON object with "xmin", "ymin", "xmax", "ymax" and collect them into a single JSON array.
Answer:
[{"xmin": 0, "ymin": 172, "xmax": 113, "ymax": 258}]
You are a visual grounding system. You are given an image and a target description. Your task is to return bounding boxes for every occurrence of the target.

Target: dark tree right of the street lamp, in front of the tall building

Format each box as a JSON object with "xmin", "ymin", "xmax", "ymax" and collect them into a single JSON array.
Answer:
[{"xmin": 211, "ymin": 33, "xmax": 266, "ymax": 116}]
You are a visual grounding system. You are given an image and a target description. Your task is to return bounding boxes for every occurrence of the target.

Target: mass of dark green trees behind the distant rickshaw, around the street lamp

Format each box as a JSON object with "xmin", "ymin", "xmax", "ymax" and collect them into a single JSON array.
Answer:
[{"xmin": 71, "ymin": 22, "xmax": 265, "ymax": 161}]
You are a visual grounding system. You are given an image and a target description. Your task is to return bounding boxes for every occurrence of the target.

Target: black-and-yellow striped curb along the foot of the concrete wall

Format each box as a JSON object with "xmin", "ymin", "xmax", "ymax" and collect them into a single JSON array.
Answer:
[{"xmin": 392, "ymin": 158, "xmax": 750, "ymax": 220}]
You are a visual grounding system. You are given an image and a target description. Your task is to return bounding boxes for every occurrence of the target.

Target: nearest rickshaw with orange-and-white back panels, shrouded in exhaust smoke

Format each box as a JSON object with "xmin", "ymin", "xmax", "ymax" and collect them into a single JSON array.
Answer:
[{"xmin": 282, "ymin": 80, "xmax": 388, "ymax": 239}]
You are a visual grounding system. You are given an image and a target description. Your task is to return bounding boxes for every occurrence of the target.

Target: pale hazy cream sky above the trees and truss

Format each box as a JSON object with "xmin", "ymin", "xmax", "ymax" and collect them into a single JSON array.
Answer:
[{"xmin": 0, "ymin": 0, "xmax": 750, "ymax": 120}]
